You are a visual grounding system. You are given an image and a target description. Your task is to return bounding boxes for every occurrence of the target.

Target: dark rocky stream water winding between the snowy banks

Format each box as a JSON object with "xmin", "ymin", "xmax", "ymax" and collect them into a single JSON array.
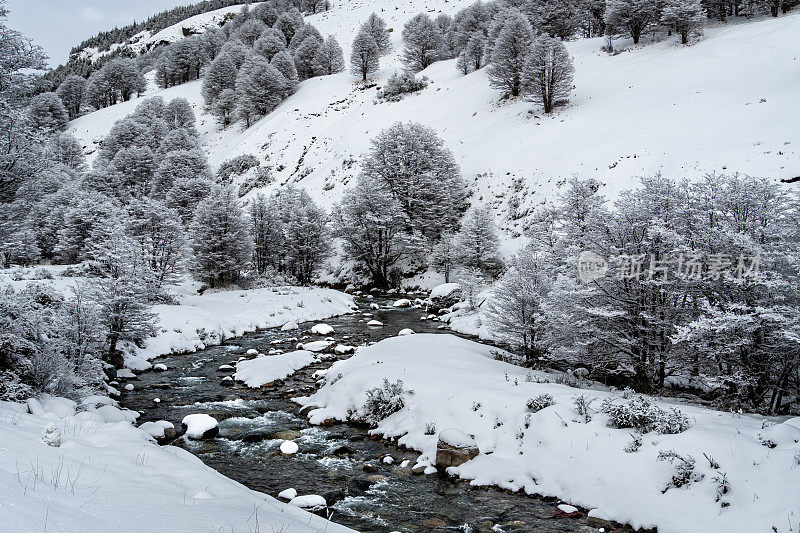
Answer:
[{"xmin": 122, "ymin": 298, "xmax": 630, "ymax": 533}]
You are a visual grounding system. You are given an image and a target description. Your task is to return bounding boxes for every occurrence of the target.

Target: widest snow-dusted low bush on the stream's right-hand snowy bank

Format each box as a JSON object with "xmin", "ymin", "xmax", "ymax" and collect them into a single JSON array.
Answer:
[{"xmin": 600, "ymin": 397, "xmax": 691, "ymax": 434}]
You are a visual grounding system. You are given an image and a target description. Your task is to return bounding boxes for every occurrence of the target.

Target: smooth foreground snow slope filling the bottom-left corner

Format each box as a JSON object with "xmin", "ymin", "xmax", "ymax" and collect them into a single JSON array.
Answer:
[{"xmin": 0, "ymin": 396, "xmax": 351, "ymax": 533}]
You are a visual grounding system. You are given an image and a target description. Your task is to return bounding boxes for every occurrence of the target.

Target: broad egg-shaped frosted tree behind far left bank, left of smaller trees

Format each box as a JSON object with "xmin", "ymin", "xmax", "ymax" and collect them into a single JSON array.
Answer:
[{"xmin": 189, "ymin": 186, "xmax": 253, "ymax": 287}]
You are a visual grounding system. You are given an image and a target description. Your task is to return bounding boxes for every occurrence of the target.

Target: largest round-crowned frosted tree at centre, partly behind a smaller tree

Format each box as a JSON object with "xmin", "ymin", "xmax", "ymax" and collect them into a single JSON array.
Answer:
[{"xmin": 362, "ymin": 122, "xmax": 466, "ymax": 239}]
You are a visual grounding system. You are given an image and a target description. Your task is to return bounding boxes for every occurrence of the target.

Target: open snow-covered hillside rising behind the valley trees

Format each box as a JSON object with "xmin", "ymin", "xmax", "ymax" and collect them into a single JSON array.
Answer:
[{"xmin": 71, "ymin": 4, "xmax": 800, "ymax": 239}]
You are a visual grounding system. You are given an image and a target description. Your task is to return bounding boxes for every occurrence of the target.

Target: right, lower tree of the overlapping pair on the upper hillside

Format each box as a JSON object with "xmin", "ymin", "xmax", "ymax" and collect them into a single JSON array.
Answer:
[{"xmin": 522, "ymin": 35, "xmax": 575, "ymax": 113}]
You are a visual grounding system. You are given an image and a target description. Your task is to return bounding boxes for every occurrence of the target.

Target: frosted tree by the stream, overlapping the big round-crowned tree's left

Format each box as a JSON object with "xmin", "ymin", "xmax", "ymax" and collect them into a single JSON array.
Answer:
[{"xmin": 332, "ymin": 176, "xmax": 420, "ymax": 287}]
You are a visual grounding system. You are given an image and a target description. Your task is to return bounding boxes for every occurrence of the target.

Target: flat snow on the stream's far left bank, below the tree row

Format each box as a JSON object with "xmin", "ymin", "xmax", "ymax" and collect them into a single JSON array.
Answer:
[{"xmin": 0, "ymin": 267, "xmax": 355, "ymax": 370}]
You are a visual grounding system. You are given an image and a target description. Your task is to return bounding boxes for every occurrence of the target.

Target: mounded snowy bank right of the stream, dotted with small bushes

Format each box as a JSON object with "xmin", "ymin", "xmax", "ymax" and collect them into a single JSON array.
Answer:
[{"xmin": 298, "ymin": 334, "xmax": 800, "ymax": 533}]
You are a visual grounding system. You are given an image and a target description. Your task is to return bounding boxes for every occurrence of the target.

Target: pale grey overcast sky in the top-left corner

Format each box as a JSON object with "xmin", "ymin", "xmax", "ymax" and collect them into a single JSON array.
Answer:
[{"xmin": 6, "ymin": 0, "xmax": 189, "ymax": 66}]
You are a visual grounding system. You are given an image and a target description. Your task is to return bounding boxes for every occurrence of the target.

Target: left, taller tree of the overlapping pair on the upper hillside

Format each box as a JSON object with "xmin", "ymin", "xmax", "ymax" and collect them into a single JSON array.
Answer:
[{"xmin": 488, "ymin": 10, "xmax": 533, "ymax": 96}]
